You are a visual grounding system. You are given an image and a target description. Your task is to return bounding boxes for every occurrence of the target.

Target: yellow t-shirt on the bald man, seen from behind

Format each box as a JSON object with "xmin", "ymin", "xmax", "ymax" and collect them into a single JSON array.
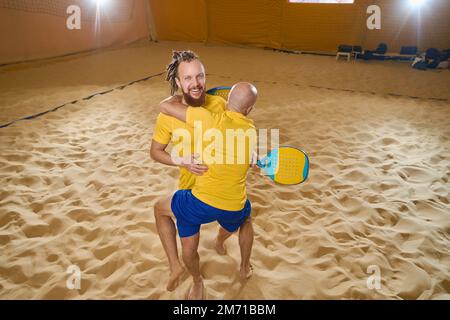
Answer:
[{"xmin": 186, "ymin": 107, "xmax": 256, "ymax": 211}]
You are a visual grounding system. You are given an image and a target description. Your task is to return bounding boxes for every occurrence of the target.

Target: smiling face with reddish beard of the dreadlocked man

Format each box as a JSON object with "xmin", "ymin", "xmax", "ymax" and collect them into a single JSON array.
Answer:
[{"xmin": 176, "ymin": 60, "xmax": 206, "ymax": 107}]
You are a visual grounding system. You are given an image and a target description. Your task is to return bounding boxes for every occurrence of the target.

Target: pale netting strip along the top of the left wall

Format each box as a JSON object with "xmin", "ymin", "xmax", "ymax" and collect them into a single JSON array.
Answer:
[{"xmin": 0, "ymin": 0, "xmax": 135, "ymax": 23}]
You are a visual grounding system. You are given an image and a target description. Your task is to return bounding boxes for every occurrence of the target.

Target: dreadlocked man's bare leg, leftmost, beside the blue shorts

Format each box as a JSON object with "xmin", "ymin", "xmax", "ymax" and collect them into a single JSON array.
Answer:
[{"xmin": 154, "ymin": 196, "xmax": 184, "ymax": 291}]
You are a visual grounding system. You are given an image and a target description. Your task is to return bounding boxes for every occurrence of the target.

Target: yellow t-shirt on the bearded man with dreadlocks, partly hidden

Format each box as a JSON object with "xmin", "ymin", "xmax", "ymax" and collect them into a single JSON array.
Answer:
[{"xmin": 153, "ymin": 94, "xmax": 225, "ymax": 189}]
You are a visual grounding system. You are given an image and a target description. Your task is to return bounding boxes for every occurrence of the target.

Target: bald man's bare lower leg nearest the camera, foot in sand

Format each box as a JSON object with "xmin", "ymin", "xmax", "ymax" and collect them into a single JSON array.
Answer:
[{"xmin": 181, "ymin": 233, "xmax": 204, "ymax": 300}]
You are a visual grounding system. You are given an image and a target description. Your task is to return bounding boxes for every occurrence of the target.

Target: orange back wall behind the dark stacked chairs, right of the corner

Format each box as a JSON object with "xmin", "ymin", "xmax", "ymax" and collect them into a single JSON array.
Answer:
[{"xmin": 149, "ymin": 0, "xmax": 450, "ymax": 52}]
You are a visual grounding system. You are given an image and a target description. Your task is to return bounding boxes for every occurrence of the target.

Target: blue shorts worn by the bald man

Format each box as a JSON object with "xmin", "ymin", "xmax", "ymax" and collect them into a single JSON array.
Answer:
[{"xmin": 171, "ymin": 190, "xmax": 252, "ymax": 238}]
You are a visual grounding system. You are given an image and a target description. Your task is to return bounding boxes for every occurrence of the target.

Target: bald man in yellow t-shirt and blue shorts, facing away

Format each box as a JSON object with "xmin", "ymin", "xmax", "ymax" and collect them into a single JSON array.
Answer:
[{"xmin": 160, "ymin": 82, "xmax": 257, "ymax": 299}]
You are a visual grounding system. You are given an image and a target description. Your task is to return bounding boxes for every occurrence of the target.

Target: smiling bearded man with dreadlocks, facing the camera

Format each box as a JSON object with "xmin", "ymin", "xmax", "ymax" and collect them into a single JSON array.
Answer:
[{"xmin": 150, "ymin": 51, "xmax": 236, "ymax": 298}]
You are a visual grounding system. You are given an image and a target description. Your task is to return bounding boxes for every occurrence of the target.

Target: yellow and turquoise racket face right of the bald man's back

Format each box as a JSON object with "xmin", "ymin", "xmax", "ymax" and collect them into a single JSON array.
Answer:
[{"xmin": 258, "ymin": 147, "xmax": 309, "ymax": 184}]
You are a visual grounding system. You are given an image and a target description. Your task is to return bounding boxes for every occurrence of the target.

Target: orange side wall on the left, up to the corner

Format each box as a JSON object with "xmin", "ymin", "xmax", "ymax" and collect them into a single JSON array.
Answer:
[{"xmin": 0, "ymin": 0, "xmax": 149, "ymax": 64}]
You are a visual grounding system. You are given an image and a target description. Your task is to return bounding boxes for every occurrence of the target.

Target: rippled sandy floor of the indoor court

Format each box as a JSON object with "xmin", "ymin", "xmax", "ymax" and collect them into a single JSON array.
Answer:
[{"xmin": 0, "ymin": 42, "xmax": 450, "ymax": 299}]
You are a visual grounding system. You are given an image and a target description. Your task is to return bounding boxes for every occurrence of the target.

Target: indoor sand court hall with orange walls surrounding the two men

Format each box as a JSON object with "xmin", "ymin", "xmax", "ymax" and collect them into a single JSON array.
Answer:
[{"xmin": 0, "ymin": 0, "xmax": 450, "ymax": 300}]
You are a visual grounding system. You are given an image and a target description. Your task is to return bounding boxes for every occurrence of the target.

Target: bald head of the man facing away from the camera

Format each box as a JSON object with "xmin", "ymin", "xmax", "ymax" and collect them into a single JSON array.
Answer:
[{"xmin": 228, "ymin": 82, "xmax": 258, "ymax": 115}]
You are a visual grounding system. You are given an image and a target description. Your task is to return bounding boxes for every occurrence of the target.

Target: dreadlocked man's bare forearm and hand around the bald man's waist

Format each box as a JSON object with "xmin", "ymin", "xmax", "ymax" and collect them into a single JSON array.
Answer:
[{"xmin": 150, "ymin": 140, "xmax": 208, "ymax": 176}]
